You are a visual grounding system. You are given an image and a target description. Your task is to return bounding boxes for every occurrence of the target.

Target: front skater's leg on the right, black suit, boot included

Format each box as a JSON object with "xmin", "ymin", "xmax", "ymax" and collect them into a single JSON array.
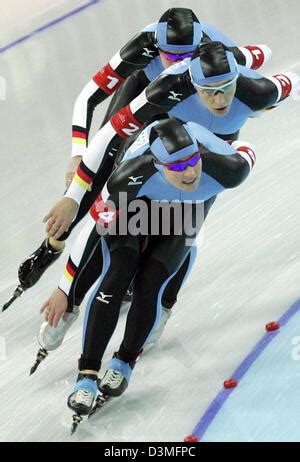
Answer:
[{"xmin": 100, "ymin": 236, "xmax": 190, "ymax": 396}]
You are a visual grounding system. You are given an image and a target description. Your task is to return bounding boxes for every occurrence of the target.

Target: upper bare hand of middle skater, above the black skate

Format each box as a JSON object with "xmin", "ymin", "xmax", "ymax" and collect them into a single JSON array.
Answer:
[{"xmin": 43, "ymin": 197, "xmax": 78, "ymax": 239}]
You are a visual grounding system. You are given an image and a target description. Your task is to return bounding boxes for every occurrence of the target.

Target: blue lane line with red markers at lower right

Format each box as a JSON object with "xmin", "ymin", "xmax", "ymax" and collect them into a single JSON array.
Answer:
[{"xmin": 192, "ymin": 300, "xmax": 300, "ymax": 441}]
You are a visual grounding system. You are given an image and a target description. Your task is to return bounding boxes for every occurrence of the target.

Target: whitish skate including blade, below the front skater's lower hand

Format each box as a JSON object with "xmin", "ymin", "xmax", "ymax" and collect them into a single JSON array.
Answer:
[{"xmin": 29, "ymin": 306, "xmax": 79, "ymax": 375}]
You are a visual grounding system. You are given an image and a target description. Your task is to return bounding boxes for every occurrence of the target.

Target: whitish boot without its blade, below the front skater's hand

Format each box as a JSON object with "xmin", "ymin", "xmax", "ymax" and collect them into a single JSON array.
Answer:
[{"xmin": 37, "ymin": 306, "xmax": 79, "ymax": 351}]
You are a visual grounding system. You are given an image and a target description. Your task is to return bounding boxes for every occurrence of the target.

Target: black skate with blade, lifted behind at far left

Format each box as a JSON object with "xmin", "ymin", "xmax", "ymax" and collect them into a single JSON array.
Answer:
[{"xmin": 2, "ymin": 239, "xmax": 63, "ymax": 311}]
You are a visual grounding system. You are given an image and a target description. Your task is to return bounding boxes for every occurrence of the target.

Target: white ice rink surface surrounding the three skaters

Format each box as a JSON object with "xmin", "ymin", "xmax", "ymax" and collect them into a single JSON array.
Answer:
[{"xmin": 0, "ymin": 0, "xmax": 300, "ymax": 442}]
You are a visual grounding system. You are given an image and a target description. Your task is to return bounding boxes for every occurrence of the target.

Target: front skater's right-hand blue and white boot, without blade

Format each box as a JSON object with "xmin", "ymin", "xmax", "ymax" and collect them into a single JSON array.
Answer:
[{"xmin": 99, "ymin": 353, "xmax": 135, "ymax": 397}]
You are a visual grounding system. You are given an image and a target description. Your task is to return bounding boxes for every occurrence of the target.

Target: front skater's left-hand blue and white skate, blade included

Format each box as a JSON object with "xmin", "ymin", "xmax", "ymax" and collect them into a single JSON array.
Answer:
[{"xmin": 68, "ymin": 374, "xmax": 98, "ymax": 435}]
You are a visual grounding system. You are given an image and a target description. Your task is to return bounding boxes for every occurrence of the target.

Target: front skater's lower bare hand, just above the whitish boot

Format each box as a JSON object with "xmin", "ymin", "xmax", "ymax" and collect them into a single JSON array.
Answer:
[{"xmin": 40, "ymin": 288, "xmax": 69, "ymax": 327}]
